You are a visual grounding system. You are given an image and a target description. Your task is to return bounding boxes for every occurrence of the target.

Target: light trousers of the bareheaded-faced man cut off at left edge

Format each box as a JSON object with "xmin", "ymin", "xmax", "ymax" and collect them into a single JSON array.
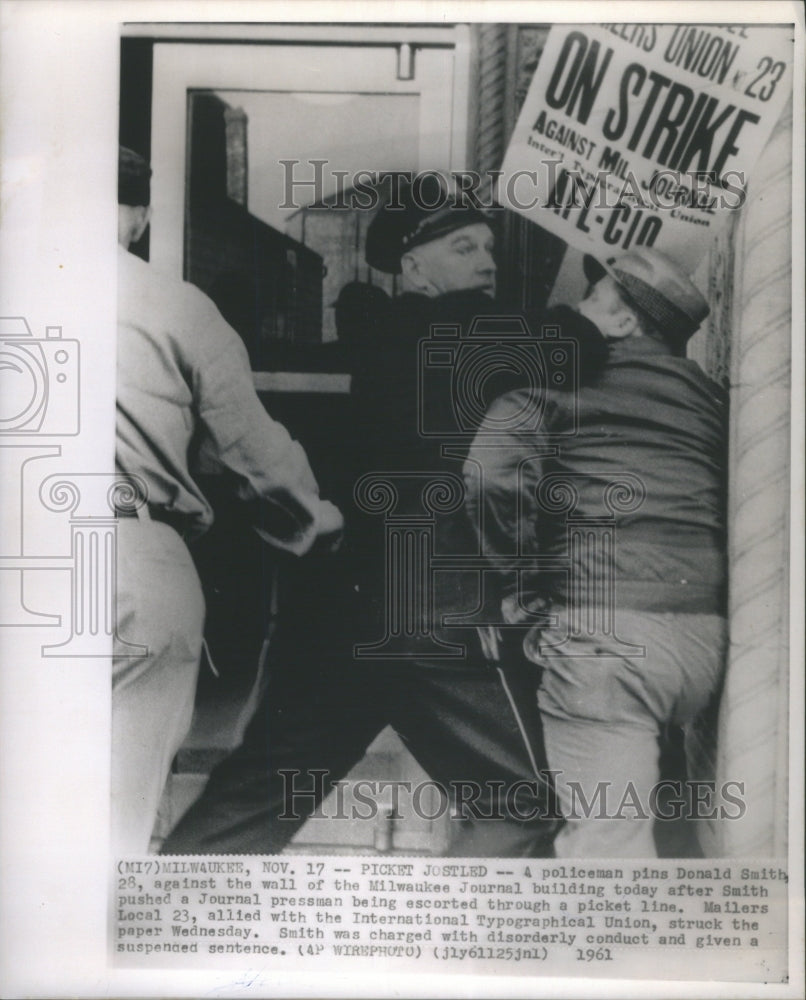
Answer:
[{"xmin": 111, "ymin": 519, "xmax": 204, "ymax": 854}]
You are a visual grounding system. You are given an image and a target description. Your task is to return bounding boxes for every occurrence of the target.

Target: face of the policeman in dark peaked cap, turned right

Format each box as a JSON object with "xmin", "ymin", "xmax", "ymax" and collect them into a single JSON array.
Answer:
[{"xmin": 401, "ymin": 222, "xmax": 495, "ymax": 297}]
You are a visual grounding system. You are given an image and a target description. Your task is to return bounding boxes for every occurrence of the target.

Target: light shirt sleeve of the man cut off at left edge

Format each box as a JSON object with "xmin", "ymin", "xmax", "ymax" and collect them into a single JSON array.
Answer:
[{"xmin": 189, "ymin": 300, "xmax": 321, "ymax": 555}]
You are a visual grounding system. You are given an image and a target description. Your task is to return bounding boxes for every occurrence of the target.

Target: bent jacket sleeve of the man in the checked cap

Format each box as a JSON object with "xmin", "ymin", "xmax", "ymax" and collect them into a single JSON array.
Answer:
[{"xmin": 464, "ymin": 389, "xmax": 547, "ymax": 616}]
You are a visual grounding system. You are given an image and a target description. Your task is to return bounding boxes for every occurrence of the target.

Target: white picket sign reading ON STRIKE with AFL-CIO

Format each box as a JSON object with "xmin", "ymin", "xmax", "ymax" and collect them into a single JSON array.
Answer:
[{"xmin": 498, "ymin": 24, "xmax": 794, "ymax": 272}]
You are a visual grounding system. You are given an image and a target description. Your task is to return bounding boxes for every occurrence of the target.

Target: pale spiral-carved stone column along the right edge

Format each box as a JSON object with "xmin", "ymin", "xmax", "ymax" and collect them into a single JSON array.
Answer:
[{"xmin": 714, "ymin": 104, "xmax": 792, "ymax": 857}]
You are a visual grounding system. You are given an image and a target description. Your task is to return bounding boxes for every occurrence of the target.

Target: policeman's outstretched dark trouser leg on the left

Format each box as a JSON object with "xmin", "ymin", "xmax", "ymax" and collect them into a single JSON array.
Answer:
[{"xmin": 162, "ymin": 624, "xmax": 386, "ymax": 854}]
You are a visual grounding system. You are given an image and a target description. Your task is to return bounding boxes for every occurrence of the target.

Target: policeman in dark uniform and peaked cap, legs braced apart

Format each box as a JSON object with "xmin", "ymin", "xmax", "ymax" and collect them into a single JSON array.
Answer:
[{"xmin": 163, "ymin": 178, "xmax": 592, "ymax": 857}]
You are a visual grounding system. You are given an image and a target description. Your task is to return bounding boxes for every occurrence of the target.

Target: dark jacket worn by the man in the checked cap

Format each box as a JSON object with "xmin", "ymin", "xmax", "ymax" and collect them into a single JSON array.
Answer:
[{"xmin": 470, "ymin": 337, "xmax": 727, "ymax": 613}]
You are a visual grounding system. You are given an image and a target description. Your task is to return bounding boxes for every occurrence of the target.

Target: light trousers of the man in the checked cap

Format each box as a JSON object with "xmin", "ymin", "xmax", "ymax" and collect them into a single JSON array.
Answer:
[{"xmin": 538, "ymin": 610, "xmax": 724, "ymax": 858}]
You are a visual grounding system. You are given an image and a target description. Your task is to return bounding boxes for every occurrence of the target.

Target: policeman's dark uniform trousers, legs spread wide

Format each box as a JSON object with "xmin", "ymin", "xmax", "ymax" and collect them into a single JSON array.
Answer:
[{"xmin": 163, "ymin": 568, "xmax": 559, "ymax": 857}]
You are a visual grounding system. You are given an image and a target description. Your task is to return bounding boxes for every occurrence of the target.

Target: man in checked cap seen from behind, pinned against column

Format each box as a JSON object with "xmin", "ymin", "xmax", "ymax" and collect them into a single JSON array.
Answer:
[{"xmin": 470, "ymin": 248, "xmax": 727, "ymax": 858}]
